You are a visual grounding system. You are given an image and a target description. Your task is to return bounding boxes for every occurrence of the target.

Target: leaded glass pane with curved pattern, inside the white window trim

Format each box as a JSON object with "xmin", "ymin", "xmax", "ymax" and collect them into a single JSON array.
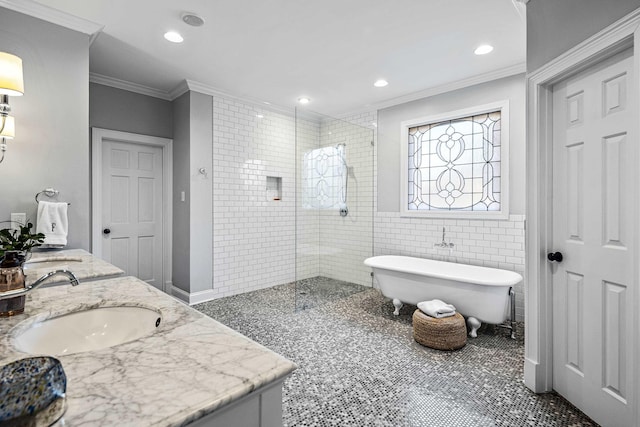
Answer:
[{"xmin": 407, "ymin": 110, "xmax": 503, "ymax": 212}]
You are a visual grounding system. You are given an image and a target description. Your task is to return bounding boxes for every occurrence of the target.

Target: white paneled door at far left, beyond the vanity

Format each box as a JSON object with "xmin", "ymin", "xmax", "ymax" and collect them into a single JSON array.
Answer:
[{"xmin": 100, "ymin": 139, "xmax": 164, "ymax": 290}]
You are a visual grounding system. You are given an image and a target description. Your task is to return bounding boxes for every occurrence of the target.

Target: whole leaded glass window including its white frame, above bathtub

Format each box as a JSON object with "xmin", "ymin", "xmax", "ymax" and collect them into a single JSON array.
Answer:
[{"xmin": 402, "ymin": 101, "xmax": 509, "ymax": 218}]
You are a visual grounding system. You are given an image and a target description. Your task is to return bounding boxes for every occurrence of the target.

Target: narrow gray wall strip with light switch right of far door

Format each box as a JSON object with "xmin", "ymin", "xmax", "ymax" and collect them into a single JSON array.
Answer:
[{"xmin": 172, "ymin": 92, "xmax": 191, "ymax": 292}]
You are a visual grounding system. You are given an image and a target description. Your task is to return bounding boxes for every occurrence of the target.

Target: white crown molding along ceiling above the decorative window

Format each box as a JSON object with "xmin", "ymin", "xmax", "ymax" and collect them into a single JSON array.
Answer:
[{"xmin": 337, "ymin": 62, "xmax": 527, "ymax": 117}]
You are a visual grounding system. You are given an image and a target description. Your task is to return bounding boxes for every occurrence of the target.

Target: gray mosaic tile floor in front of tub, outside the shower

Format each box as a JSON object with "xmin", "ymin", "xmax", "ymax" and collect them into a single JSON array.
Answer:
[{"xmin": 195, "ymin": 284, "xmax": 597, "ymax": 427}]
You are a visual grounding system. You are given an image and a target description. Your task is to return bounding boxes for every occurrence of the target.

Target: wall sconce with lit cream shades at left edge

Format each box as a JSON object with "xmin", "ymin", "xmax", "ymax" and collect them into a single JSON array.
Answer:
[{"xmin": 0, "ymin": 52, "xmax": 24, "ymax": 163}]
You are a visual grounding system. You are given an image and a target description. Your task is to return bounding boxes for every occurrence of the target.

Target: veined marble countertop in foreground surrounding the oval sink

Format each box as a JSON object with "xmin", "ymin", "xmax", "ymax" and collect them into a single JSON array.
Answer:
[{"xmin": 0, "ymin": 277, "xmax": 296, "ymax": 426}]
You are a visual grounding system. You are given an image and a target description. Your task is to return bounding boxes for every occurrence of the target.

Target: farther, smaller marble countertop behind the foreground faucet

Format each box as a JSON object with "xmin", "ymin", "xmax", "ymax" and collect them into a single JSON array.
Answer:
[{"xmin": 24, "ymin": 249, "xmax": 124, "ymax": 286}]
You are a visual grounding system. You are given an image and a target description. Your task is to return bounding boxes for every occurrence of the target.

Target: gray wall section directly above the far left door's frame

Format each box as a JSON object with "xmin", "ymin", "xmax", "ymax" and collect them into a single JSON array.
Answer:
[{"xmin": 89, "ymin": 83, "xmax": 173, "ymax": 138}]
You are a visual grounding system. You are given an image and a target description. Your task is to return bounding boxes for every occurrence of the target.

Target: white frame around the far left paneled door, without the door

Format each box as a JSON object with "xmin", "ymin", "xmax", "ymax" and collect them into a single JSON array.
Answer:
[{"xmin": 91, "ymin": 127, "xmax": 173, "ymax": 295}]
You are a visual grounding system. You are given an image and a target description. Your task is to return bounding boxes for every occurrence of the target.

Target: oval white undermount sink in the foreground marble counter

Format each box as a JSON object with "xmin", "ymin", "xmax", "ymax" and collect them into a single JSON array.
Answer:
[{"xmin": 13, "ymin": 306, "xmax": 162, "ymax": 356}]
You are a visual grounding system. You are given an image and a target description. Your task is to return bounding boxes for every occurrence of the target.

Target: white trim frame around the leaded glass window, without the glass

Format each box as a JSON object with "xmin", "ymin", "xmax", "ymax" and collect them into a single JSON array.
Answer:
[{"xmin": 400, "ymin": 100, "xmax": 510, "ymax": 220}]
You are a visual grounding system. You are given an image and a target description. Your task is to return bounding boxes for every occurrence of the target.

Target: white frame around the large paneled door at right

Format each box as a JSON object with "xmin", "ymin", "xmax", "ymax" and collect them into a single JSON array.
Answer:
[{"xmin": 524, "ymin": 5, "xmax": 640, "ymax": 420}]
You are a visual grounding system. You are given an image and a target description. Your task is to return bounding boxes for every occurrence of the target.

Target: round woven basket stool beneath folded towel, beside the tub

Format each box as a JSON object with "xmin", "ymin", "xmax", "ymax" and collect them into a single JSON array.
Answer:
[{"xmin": 413, "ymin": 310, "xmax": 467, "ymax": 350}]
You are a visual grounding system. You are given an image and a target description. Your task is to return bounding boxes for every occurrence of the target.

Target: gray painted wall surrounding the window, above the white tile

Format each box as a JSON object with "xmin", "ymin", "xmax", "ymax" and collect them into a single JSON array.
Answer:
[{"xmin": 378, "ymin": 74, "xmax": 525, "ymax": 215}]
